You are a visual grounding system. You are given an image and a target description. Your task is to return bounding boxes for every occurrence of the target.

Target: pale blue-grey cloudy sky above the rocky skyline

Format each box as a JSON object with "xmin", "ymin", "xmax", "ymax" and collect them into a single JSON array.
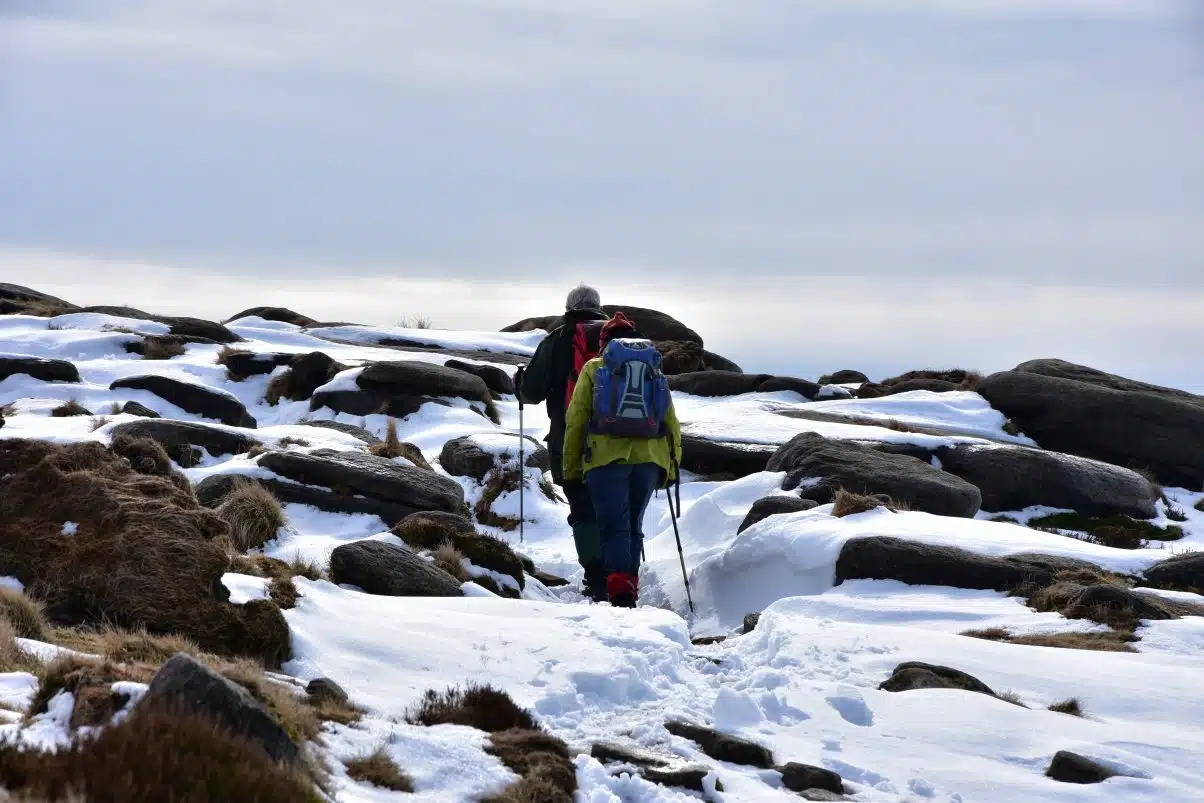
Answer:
[{"xmin": 0, "ymin": 0, "xmax": 1204, "ymax": 392}]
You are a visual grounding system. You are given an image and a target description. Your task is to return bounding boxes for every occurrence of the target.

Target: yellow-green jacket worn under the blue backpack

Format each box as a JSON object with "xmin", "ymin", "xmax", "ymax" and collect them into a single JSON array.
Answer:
[{"xmin": 565, "ymin": 358, "xmax": 681, "ymax": 482}]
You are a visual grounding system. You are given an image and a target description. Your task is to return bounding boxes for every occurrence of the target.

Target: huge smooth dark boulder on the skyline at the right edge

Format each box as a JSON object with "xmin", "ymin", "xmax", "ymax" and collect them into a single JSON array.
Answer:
[{"xmin": 978, "ymin": 361, "xmax": 1204, "ymax": 488}]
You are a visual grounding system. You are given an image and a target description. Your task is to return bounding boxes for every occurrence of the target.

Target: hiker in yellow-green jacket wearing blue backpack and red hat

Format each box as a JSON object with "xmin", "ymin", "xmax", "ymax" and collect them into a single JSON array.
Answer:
[{"xmin": 563, "ymin": 313, "xmax": 681, "ymax": 608}]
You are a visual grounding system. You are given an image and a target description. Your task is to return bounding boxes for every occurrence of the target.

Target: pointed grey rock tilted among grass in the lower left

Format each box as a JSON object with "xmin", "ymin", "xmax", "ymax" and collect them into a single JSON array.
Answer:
[{"xmin": 138, "ymin": 653, "xmax": 301, "ymax": 764}]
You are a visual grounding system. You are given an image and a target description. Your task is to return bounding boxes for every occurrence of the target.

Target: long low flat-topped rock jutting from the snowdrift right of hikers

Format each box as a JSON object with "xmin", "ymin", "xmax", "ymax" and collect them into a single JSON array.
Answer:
[{"xmin": 836, "ymin": 536, "xmax": 1063, "ymax": 591}]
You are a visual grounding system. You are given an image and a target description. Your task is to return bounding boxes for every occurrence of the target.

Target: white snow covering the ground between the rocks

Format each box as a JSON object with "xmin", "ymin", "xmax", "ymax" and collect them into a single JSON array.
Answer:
[{"xmin": 0, "ymin": 314, "xmax": 1204, "ymax": 803}]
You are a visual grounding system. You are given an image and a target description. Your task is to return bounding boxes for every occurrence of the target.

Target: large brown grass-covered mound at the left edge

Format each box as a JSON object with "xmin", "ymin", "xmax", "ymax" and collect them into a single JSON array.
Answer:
[{"xmin": 0, "ymin": 439, "xmax": 289, "ymax": 666}]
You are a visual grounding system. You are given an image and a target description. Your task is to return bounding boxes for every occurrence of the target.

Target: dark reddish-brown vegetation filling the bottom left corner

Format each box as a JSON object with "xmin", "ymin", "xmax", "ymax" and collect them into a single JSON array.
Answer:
[{"xmin": 0, "ymin": 708, "xmax": 321, "ymax": 803}]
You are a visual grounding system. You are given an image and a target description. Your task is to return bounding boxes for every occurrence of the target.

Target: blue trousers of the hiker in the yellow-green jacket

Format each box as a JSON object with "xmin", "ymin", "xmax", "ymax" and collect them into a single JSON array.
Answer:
[{"xmin": 585, "ymin": 462, "xmax": 663, "ymax": 575}]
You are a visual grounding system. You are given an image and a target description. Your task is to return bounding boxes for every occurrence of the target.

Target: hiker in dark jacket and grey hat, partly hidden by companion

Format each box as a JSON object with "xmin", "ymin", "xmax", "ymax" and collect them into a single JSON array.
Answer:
[{"xmin": 519, "ymin": 284, "xmax": 607, "ymax": 600}]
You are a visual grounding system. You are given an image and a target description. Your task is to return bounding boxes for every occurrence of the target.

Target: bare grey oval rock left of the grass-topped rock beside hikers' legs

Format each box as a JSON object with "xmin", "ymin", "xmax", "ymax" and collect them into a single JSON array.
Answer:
[{"xmin": 330, "ymin": 541, "xmax": 464, "ymax": 597}]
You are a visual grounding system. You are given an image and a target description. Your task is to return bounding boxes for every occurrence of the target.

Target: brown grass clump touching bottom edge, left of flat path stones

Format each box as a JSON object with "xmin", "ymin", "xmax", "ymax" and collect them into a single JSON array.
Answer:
[{"xmin": 485, "ymin": 728, "xmax": 577, "ymax": 803}]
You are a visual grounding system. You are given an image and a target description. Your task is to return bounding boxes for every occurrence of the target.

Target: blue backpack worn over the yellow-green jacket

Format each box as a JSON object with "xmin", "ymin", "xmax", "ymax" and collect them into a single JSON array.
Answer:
[{"xmin": 590, "ymin": 339, "xmax": 672, "ymax": 438}]
